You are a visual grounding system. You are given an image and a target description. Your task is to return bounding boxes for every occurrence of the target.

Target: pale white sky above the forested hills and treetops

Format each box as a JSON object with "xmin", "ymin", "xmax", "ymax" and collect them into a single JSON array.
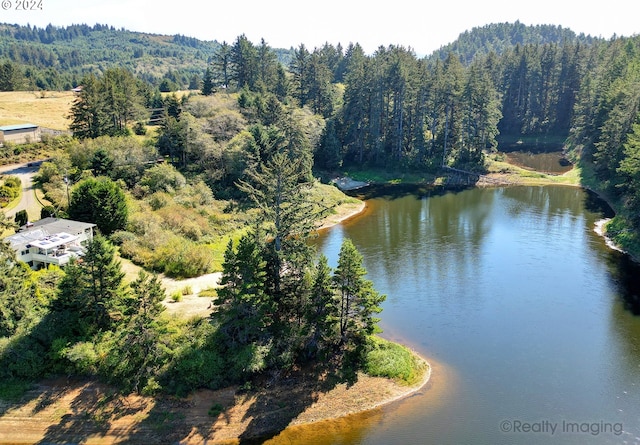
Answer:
[{"xmin": 0, "ymin": 0, "xmax": 640, "ymax": 56}]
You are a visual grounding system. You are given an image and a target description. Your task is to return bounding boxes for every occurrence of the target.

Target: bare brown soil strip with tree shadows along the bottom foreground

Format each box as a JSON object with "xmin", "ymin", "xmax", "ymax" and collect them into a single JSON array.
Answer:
[{"xmin": 0, "ymin": 358, "xmax": 430, "ymax": 445}]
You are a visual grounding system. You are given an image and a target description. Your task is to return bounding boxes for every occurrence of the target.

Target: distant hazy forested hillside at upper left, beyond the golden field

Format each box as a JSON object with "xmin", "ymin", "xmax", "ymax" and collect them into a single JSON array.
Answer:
[{"xmin": 0, "ymin": 24, "xmax": 289, "ymax": 91}]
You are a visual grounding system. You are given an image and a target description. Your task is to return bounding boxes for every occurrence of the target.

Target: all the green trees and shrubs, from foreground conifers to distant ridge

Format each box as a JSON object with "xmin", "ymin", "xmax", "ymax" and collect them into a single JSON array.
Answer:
[{"xmin": 0, "ymin": 23, "xmax": 640, "ymax": 393}]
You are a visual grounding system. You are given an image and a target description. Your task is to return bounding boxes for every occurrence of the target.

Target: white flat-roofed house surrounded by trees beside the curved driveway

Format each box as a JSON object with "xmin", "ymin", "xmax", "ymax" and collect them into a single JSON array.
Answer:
[{"xmin": 4, "ymin": 218, "xmax": 96, "ymax": 270}]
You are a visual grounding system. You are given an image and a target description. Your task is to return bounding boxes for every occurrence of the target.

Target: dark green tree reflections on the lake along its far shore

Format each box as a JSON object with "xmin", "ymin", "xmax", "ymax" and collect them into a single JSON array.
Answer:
[{"xmin": 317, "ymin": 186, "xmax": 606, "ymax": 308}]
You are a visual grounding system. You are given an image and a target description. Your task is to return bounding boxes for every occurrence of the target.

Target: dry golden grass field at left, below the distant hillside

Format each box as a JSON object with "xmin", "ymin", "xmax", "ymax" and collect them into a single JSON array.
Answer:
[{"xmin": 0, "ymin": 91, "xmax": 75, "ymax": 130}]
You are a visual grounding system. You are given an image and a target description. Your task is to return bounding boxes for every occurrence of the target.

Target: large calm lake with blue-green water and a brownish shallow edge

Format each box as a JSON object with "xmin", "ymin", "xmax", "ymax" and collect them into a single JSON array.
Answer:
[{"xmin": 269, "ymin": 187, "xmax": 640, "ymax": 445}]
